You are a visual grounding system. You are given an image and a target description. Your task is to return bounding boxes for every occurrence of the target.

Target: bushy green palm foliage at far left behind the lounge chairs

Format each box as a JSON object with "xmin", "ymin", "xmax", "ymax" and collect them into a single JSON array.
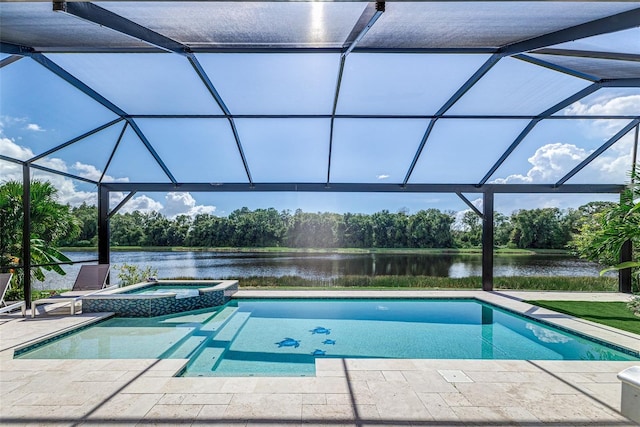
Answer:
[{"xmin": 0, "ymin": 180, "xmax": 80, "ymax": 286}]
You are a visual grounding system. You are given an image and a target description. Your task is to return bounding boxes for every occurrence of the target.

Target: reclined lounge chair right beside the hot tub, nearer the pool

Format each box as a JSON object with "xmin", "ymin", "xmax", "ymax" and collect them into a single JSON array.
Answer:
[{"xmin": 31, "ymin": 264, "xmax": 115, "ymax": 317}]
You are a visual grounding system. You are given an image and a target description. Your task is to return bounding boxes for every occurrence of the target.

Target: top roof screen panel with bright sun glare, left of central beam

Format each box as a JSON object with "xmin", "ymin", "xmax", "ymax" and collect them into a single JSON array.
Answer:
[{"xmin": 97, "ymin": 2, "xmax": 367, "ymax": 48}]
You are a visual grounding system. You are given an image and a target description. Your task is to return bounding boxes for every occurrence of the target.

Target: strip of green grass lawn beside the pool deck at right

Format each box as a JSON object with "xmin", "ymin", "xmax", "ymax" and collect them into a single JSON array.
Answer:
[{"xmin": 525, "ymin": 301, "xmax": 640, "ymax": 335}]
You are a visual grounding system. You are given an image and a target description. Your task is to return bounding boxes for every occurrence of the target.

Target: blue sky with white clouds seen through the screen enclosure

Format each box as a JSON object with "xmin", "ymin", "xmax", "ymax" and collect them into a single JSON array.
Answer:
[{"xmin": 0, "ymin": 28, "xmax": 640, "ymax": 217}]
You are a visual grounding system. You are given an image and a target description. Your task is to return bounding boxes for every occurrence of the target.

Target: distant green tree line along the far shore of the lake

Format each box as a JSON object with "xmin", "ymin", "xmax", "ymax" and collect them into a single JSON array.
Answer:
[{"xmin": 57, "ymin": 202, "xmax": 611, "ymax": 249}]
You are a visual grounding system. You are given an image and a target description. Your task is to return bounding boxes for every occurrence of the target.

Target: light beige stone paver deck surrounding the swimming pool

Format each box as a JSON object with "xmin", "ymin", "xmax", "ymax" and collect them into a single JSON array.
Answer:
[{"xmin": 0, "ymin": 291, "xmax": 640, "ymax": 426}]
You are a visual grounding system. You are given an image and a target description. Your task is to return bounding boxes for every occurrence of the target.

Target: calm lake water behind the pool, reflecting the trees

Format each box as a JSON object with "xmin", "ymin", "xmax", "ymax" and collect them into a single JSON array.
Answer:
[{"xmin": 34, "ymin": 251, "xmax": 600, "ymax": 289}]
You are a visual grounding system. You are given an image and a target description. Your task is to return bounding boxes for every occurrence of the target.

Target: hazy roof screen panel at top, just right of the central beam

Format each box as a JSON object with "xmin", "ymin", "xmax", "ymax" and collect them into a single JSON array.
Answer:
[{"xmin": 360, "ymin": 1, "xmax": 637, "ymax": 48}]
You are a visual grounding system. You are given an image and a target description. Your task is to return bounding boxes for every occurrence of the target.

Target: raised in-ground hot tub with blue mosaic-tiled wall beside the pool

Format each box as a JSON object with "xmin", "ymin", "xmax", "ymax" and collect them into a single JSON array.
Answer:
[{"xmin": 82, "ymin": 280, "xmax": 238, "ymax": 317}]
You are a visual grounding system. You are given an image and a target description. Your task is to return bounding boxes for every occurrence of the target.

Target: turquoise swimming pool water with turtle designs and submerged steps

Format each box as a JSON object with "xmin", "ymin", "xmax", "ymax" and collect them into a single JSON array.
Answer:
[{"xmin": 17, "ymin": 299, "xmax": 638, "ymax": 376}]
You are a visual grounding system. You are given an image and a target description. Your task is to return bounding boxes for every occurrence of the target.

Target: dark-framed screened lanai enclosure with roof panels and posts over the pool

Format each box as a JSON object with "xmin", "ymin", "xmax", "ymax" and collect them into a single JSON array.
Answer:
[{"xmin": 0, "ymin": 0, "xmax": 640, "ymax": 300}]
